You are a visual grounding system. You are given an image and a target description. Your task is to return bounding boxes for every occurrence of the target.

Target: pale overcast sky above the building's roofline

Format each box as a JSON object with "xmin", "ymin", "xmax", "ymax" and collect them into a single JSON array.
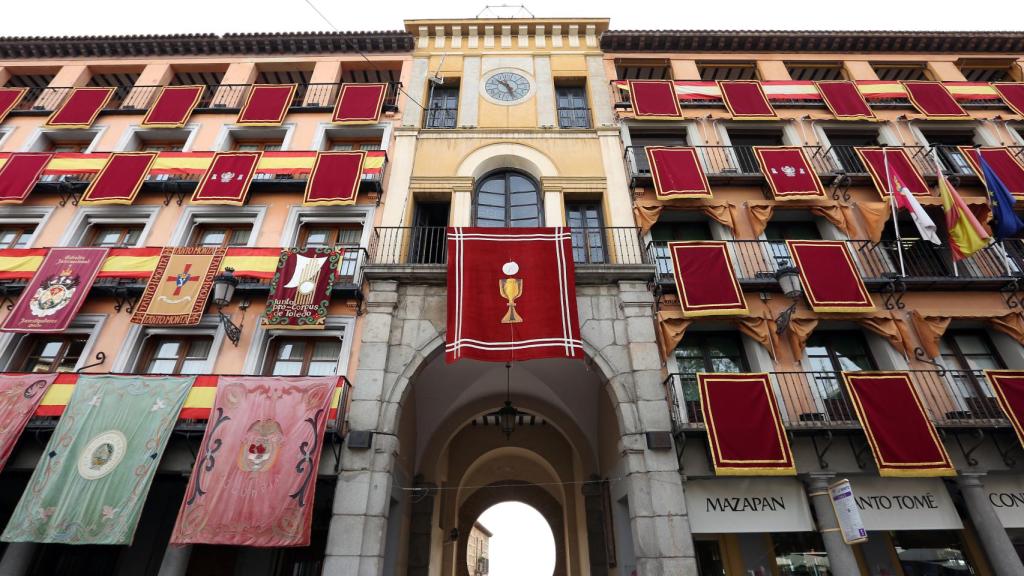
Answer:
[{"xmin": 0, "ymin": 0, "xmax": 1024, "ymax": 36}]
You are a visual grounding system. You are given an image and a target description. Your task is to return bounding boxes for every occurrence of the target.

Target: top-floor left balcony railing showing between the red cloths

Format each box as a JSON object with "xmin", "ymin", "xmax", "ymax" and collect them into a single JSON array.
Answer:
[{"xmin": 11, "ymin": 82, "xmax": 401, "ymax": 115}]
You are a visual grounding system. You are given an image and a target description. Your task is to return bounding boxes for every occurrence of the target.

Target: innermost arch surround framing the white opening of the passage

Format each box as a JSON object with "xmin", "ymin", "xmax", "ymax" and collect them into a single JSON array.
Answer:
[{"xmin": 456, "ymin": 481, "xmax": 567, "ymax": 576}]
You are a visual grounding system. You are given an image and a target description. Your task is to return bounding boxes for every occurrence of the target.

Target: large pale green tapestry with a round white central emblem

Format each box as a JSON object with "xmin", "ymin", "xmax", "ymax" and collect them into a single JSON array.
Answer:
[{"xmin": 0, "ymin": 375, "xmax": 196, "ymax": 544}]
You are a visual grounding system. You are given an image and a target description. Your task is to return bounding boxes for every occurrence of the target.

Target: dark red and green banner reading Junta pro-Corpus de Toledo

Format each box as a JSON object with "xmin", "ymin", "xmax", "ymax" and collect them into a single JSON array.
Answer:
[{"xmin": 262, "ymin": 248, "xmax": 342, "ymax": 330}]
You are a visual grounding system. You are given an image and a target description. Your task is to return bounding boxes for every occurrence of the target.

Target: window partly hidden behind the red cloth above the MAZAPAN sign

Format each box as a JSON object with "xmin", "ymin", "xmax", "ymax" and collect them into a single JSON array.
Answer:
[{"xmin": 676, "ymin": 331, "xmax": 750, "ymax": 422}]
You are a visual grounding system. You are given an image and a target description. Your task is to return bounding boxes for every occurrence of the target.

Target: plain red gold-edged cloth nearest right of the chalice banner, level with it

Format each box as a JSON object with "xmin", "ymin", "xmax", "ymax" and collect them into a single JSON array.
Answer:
[{"xmin": 669, "ymin": 240, "xmax": 749, "ymax": 317}]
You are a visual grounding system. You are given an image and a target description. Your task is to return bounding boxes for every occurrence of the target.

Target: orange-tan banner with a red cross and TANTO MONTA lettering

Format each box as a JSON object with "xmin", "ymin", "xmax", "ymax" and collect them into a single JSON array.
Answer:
[{"xmin": 131, "ymin": 247, "xmax": 225, "ymax": 326}]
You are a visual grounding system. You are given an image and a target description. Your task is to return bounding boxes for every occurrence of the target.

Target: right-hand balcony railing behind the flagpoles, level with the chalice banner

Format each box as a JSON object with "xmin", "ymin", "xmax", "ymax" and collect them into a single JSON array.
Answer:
[{"xmin": 647, "ymin": 240, "xmax": 1024, "ymax": 292}]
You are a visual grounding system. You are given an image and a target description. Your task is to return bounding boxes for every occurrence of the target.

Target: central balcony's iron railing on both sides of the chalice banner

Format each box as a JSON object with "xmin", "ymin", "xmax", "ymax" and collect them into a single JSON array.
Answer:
[{"xmin": 370, "ymin": 227, "xmax": 650, "ymax": 265}]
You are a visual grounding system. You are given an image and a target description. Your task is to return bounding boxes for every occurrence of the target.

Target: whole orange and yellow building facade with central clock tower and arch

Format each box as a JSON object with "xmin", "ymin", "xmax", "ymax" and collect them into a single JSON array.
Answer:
[{"xmin": 0, "ymin": 18, "xmax": 1024, "ymax": 576}]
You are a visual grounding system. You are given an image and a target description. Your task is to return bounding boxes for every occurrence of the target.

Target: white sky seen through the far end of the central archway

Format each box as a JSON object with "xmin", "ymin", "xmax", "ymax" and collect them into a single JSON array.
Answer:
[{"xmin": 478, "ymin": 502, "xmax": 555, "ymax": 576}]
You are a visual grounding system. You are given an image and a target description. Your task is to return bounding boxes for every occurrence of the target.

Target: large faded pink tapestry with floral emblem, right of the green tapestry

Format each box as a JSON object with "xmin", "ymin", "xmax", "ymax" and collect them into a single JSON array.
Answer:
[{"xmin": 171, "ymin": 376, "xmax": 338, "ymax": 546}]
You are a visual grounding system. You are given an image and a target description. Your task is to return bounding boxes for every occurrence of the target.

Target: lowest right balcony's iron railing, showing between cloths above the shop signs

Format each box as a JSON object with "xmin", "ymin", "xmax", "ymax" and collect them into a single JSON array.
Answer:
[{"xmin": 665, "ymin": 370, "xmax": 1008, "ymax": 430}]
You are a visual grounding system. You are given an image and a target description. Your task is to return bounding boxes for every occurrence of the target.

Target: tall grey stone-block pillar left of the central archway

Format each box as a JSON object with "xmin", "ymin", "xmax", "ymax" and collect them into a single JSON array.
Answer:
[{"xmin": 323, "ymin": 280, "xmax": 398, "ymax": 576}]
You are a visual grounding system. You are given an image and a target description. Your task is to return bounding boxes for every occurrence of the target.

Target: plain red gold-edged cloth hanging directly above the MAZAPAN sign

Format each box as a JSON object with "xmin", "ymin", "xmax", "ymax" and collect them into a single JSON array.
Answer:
[{"xmin": 697, "ymin": 374, "xmax": 797, "ymax": 476}]
